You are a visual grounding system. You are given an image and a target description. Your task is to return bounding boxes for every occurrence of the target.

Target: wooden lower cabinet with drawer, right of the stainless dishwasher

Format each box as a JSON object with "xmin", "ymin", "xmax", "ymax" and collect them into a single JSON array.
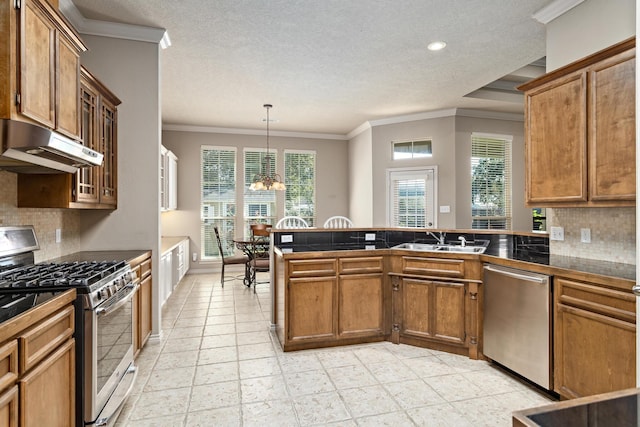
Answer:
[{"xmin": 554, "ymin": 277, "xmax": 636, "ymax": 399}]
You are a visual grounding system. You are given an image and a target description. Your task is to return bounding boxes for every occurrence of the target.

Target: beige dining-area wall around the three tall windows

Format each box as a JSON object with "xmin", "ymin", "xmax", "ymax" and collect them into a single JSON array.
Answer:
[{"xmin": 161, "ymin": 130, "xmax": 349, "ymax": 271}]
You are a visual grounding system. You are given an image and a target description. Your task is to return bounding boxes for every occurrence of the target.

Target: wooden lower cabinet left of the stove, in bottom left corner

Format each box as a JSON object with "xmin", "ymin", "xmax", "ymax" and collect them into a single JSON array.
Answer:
[{"xmin": 0, "ymin": 289, "xmax": 76, "ymax": 427}]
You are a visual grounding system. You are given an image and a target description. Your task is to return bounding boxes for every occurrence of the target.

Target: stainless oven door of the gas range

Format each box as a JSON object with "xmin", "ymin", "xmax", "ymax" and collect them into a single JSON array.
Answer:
[{"xmin": 83, "ymin": 283, "xmax": 137, "ymax": 426}]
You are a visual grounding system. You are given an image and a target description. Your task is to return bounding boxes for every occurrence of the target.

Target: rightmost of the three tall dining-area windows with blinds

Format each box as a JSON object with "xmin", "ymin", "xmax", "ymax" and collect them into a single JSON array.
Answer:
[{"xmin": 284, "ymin": 150, "xmax": 316, "ymax": 227}]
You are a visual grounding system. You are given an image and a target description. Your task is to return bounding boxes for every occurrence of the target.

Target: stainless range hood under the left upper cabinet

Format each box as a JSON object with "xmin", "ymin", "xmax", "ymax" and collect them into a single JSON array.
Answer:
[{"xmin": 0, "ymin": 119, "xmax": 104, "ymax": 173}]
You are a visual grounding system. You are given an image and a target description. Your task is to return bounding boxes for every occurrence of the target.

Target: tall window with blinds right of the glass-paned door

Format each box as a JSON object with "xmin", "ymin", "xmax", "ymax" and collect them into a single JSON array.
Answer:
[{"xmin": 471, "ymin": 134, "xmax": 512, "ymax": 230}]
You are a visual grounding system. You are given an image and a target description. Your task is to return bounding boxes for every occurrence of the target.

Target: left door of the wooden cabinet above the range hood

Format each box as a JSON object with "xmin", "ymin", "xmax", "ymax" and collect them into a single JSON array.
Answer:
[{"xmin": 20, "ymin": 1, "xmax": 56, "ymax": 129}]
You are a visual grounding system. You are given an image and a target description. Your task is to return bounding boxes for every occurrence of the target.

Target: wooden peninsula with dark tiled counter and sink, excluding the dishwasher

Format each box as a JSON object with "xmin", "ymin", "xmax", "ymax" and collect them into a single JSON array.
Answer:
[{"xmin": 271, "ymin": 229, "xmax": 635, "ymax": 398}]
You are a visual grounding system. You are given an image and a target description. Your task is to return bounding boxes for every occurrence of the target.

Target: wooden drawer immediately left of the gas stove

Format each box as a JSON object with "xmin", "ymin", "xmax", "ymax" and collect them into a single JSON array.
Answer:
[{"xmin": 18, "ymin": 306, "xmax": 74, "ymax": 373}]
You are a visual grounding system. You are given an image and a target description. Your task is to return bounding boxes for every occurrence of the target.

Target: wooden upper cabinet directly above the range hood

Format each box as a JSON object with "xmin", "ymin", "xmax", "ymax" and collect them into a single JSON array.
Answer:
[{"xmin": 7, "ymin": 0, "xmax": 87, "ymax": 139}]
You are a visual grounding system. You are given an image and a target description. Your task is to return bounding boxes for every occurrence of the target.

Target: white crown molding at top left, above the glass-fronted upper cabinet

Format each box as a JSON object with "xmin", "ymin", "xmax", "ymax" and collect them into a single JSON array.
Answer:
[{"xmin": 59, "ymin": 0, "xmax": 171, "ymax": 49}]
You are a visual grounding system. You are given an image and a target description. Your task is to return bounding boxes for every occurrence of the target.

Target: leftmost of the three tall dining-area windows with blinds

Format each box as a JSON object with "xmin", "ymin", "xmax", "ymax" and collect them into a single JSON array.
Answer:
[{"xmin": 200, "ymin": 146, "xmax": 236, "ymax": 260}]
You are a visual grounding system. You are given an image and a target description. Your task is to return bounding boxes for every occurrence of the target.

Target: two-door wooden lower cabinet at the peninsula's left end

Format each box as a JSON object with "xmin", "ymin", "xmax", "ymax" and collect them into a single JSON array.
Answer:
[{"xmin": 276, "ymin": 256, "xmax": 390, "ymax": 351}]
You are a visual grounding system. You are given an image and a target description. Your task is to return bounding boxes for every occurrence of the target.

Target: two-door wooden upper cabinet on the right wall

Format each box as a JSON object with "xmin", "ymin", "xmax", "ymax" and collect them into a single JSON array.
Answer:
[{"xmin": 519, "ymin": 39, "xmax": 635, "ymax": 207}]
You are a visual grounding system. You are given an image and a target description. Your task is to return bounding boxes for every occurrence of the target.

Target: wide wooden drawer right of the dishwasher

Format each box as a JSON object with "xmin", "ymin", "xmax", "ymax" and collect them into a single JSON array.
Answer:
[{"xmin": 555, "ymin": 277, "xmax": 636, "ymax": 323}]
